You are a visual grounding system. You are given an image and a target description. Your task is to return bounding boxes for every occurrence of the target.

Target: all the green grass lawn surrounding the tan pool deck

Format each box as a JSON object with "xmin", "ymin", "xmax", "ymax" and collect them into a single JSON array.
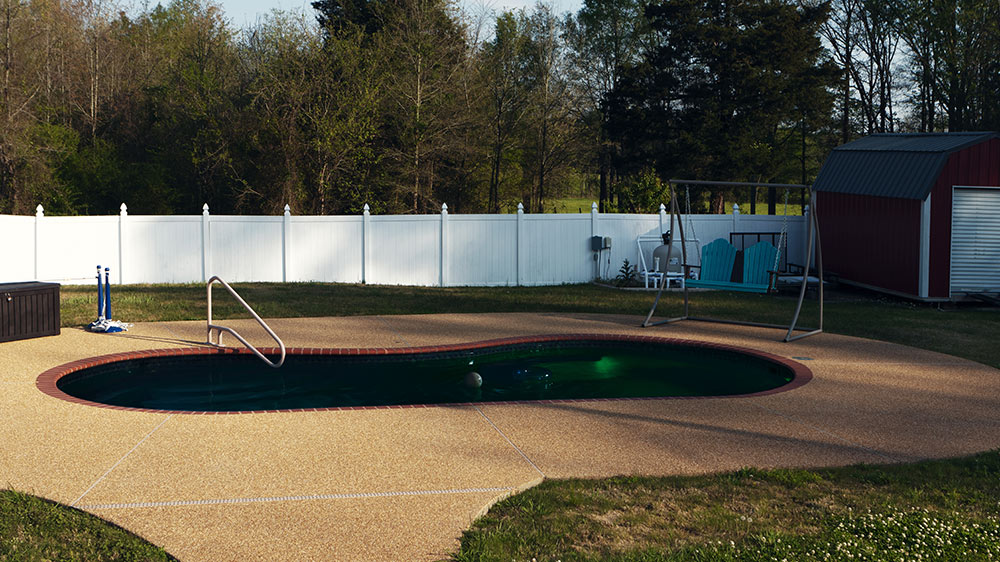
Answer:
[{"xmin": 7, "ymin": 283, "xmax": 1000, "ymax": 562}]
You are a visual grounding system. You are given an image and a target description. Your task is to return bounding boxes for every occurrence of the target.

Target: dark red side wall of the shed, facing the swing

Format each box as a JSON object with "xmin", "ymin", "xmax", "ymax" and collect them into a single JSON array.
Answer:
[{"xmin": 816, "ymin": 192, "xmax": 921, "ymax": 296}]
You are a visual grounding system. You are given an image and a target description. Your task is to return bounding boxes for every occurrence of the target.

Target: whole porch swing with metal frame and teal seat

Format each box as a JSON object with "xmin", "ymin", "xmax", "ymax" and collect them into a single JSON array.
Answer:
[{"xmin": 642, "ymin": 179, "xmax": 823, "ymax": 342}]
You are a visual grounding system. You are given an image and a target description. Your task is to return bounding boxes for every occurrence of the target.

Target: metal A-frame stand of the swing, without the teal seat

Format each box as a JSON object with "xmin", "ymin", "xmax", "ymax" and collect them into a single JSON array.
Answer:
[{"xmin": 642, "ymin": 179, "xmax": 823, "ymax": 342}]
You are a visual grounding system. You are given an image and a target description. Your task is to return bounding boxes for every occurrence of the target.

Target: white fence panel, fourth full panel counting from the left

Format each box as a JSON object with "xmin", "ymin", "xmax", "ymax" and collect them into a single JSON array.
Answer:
[{"xmin": 288, "ymin": 217, "xmax": 364, "ymax": 283}]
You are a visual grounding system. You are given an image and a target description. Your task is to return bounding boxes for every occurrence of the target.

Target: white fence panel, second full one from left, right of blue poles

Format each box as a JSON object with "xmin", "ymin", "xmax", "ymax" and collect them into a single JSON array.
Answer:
[{"xmin": 122, "ymin": 215, "xmax": 202, "ymax": 283}]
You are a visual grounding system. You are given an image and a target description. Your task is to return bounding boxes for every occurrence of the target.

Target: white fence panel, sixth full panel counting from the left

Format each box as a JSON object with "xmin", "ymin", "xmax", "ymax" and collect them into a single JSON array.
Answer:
[{"xmin": 447, "ymin": 215, "xmax": 517, "ymax": 286}]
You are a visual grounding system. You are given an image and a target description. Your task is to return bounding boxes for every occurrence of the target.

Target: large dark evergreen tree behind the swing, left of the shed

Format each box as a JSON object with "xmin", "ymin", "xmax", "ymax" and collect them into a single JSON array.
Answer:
[{"xmin": 609, "ymin": 0, "xmax": 839, "ymax": 212}]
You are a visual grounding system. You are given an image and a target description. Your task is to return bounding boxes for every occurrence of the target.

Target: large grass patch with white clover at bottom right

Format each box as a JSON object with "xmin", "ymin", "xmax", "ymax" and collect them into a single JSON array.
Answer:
[{"xmin": 454, "ymin": 451, "xmax": 1000, "ymax": 562}]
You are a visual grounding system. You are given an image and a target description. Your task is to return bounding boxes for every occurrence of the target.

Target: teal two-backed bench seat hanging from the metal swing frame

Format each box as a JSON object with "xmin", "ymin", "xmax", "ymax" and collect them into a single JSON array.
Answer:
[{"xmin": 687, "ymin": 238, "xmax": 778, "ymax": 293}]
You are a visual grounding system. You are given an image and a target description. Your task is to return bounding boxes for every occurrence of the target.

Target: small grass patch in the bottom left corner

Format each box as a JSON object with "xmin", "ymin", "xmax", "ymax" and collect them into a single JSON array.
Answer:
[{"xmin": 0, "ymin": 490, "xmax": 176, "ymax": 562}]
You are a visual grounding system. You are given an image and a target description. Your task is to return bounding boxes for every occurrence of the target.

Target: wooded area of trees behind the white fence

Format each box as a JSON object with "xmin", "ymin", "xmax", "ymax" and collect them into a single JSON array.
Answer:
[{"xmin": 0, "ymin": 0, "xmax": 1000, "ymax": 214}]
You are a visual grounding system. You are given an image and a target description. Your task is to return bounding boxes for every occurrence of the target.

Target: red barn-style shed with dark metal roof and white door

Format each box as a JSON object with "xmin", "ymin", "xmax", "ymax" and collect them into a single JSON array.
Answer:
[{"xmin": 813, "ymin": 133, "xmax": 1000, "ymax": 301}]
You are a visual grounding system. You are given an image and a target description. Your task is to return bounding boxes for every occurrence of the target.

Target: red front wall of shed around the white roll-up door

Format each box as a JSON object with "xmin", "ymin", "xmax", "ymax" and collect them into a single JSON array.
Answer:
[{"xmin": 928, "ymin": 139, "xmax": 1000, "ymax": 298}]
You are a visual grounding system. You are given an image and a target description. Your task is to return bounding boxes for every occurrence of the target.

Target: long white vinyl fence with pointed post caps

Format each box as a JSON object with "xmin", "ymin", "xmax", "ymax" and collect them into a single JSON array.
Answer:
[{"xmin": 0, "ymin": 204, "xmax": 807, "ymax": 286}]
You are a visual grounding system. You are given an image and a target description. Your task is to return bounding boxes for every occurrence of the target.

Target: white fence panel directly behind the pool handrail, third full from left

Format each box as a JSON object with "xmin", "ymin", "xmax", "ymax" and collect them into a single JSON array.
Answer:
[{"xmin": 207, "ymin": 215, "xmax": 282, "ymax": 283}]
